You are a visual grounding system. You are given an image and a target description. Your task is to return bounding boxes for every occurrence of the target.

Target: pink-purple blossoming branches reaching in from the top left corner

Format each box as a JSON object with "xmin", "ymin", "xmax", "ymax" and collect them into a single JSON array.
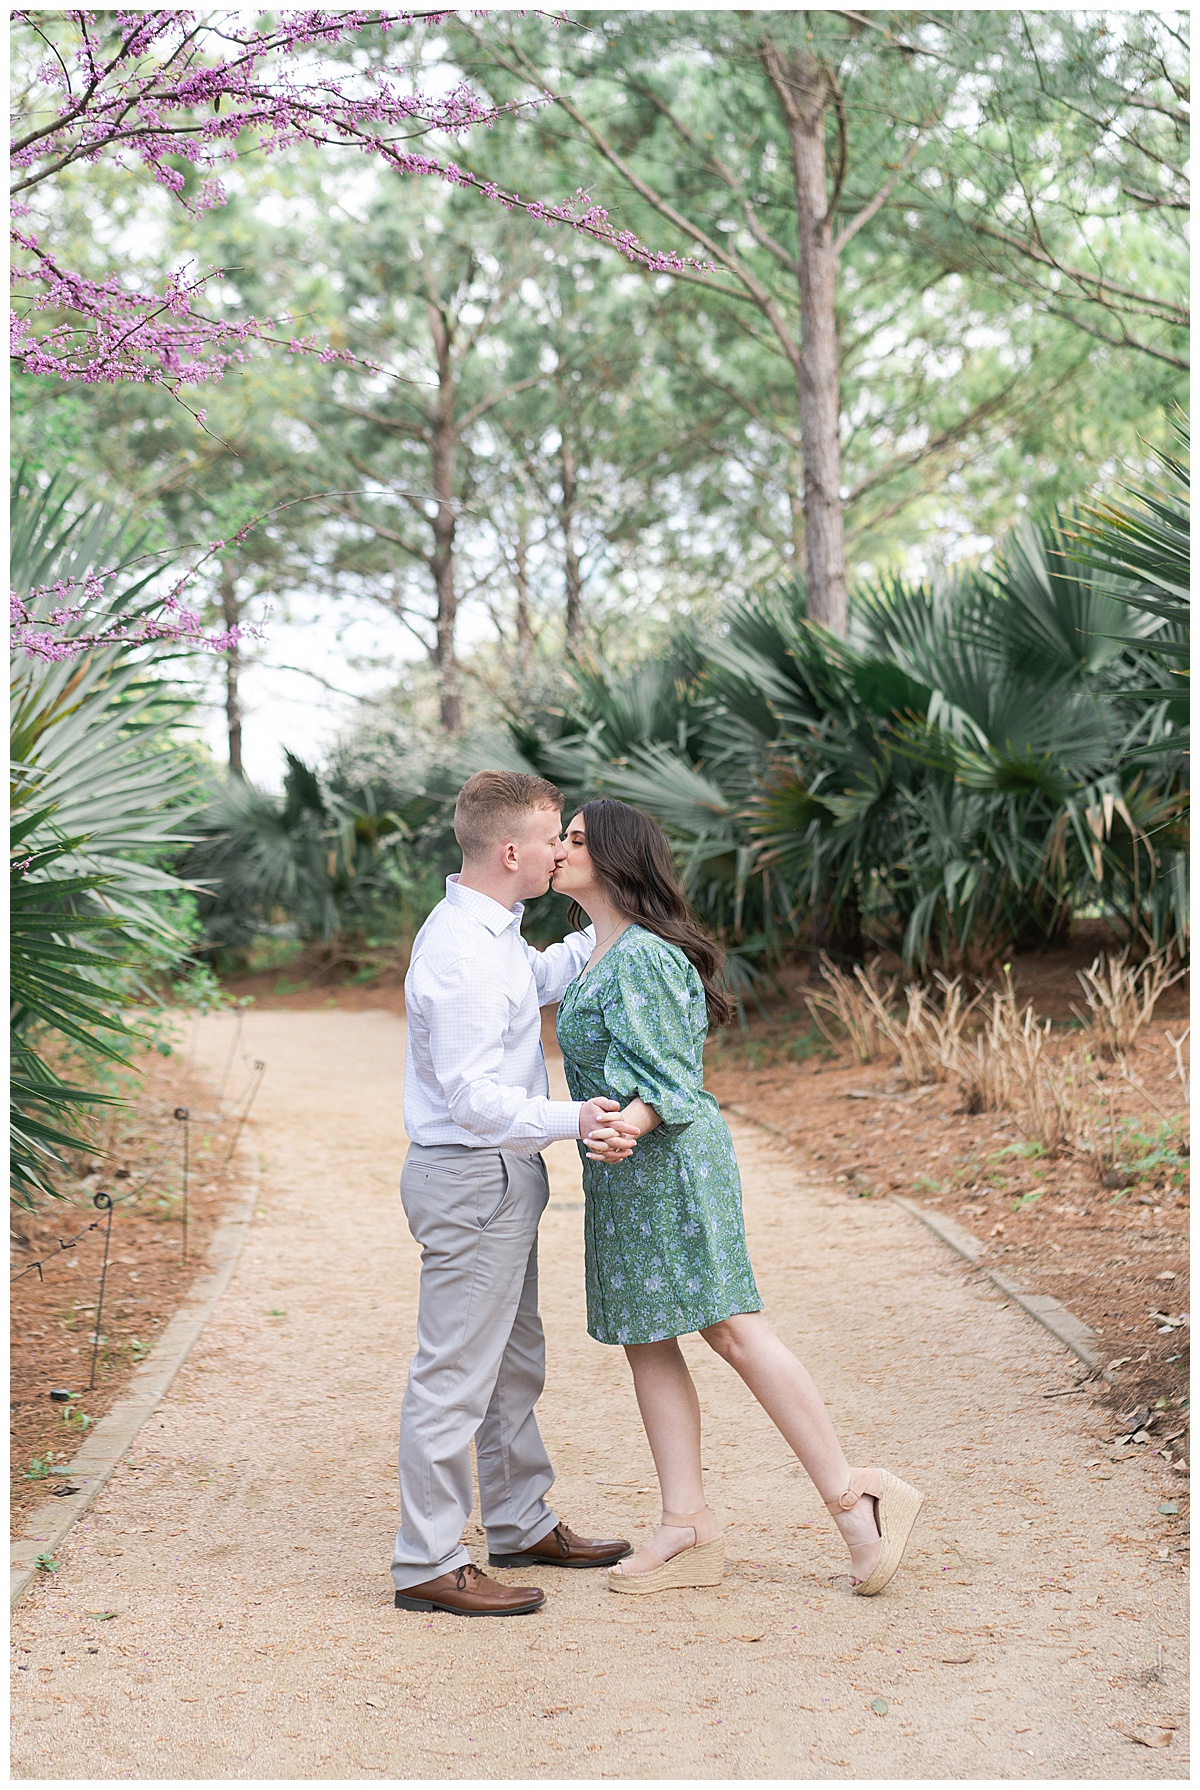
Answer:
[{"xmin": 11, "ymin": 9, "xmax": 711, "ymax": 388}]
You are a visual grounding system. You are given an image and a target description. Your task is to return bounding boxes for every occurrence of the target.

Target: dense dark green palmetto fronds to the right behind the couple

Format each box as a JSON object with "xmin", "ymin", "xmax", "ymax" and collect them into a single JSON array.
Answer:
[{"xmin": 512, "ymin": 434, "xmax": 1187, "ymax": 977}]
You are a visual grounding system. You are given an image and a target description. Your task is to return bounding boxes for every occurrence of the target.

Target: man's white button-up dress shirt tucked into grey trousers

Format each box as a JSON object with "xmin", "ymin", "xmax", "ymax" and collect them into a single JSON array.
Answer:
[{"xmin": 405, "ymin": 877, "xmax": 596, "ymax": 1151}]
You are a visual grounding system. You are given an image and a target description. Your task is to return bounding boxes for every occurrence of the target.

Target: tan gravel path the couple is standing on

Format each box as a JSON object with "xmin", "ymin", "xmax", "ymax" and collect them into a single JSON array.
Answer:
[{"xmin": 13, "ymin": 1011, "xmax": 1187, "ymax": 1779}]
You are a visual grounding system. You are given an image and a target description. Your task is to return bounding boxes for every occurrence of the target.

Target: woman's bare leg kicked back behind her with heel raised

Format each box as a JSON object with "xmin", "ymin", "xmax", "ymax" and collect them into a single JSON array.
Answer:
[{"xmin": 700, "ymin": 1312, "xmax": 879, "ymax": 1577}]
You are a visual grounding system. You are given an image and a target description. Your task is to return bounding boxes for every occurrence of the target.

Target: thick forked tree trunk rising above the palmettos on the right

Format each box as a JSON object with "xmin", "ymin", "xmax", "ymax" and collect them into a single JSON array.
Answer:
[{"xmin": 763, "ymin": 43, "xmax": 845, "ymax": 635}]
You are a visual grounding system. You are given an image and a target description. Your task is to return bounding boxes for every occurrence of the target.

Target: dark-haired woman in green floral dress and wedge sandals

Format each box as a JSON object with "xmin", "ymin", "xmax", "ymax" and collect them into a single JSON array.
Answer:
[{"xmin": 553, "ymin": 800, "xmax": 921, "ymax": 1597}]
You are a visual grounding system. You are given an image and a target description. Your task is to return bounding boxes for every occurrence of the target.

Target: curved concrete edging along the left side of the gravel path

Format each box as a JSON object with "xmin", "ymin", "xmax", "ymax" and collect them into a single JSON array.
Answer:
[{"xmin": 9, "ymin": 1147, "xmax": 260, "ymax": 1609}]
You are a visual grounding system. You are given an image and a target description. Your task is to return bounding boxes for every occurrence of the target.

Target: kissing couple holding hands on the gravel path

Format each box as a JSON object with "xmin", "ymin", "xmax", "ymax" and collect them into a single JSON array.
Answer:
[{"xmin": 392, "ymin": 771, "xmax": 922, "ymax": 1616}]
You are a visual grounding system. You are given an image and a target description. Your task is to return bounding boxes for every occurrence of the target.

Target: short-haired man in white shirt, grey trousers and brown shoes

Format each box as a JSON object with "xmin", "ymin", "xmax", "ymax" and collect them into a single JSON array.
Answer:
[{"xmin": 392, "ymin": 771, "xmax": 634, "ymax": 1616}]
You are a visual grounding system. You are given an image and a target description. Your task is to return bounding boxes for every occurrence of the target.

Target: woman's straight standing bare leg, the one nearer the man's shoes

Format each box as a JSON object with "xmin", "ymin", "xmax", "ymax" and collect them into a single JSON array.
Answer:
[{"xmin": 613, "ymin": 1337, "xmax": 716, "ymax": 1573}]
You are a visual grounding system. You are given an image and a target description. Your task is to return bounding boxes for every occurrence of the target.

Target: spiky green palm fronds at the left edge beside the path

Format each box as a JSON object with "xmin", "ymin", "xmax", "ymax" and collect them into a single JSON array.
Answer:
[{"xmin": 9, "ymin": 469, "xmax": 206, "ymax": 1205}]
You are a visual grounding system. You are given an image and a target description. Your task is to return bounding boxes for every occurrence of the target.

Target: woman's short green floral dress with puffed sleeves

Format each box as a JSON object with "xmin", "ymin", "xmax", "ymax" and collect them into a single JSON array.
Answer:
[{"xmin": 559, "ymin": 925, "xmax": 763, "ymax": 1343}]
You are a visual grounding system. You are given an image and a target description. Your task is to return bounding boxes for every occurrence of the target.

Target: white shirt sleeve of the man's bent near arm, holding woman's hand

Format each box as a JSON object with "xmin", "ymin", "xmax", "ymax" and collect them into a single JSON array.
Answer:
[{"xmin": 421, "ymin": 958, "xmax": 582, "ymax": 1151}]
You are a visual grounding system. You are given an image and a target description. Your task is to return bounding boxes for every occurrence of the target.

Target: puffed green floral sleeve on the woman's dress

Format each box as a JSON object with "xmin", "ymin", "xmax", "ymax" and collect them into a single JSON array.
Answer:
[{"xmin": 604, "ymin": 945, "xmax": 704, "ymax": 1129}]
